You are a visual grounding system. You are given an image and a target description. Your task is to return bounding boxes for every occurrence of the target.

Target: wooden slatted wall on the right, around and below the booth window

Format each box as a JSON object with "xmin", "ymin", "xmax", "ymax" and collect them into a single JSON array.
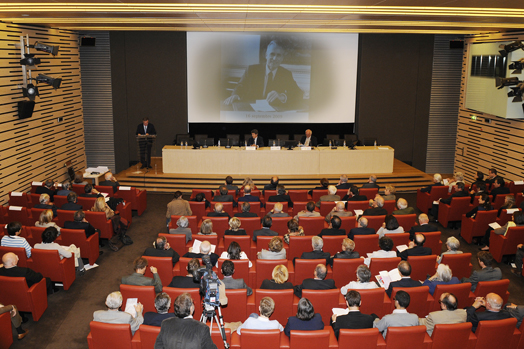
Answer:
[{"xmin": 455, "ymin": 31, "xmax": 524, "ymax": 182}]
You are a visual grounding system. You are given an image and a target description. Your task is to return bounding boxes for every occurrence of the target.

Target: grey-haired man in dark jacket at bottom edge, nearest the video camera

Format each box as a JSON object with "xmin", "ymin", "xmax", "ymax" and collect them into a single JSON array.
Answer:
[{"xmin": 155, "ymin": 293, "xmax": 216, "ymax": 349}]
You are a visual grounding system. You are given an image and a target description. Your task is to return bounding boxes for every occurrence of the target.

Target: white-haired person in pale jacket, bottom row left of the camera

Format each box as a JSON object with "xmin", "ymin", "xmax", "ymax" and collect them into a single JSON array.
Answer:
[{"xmin": 93, "ymin": 291, "xmax": 144, "ymax": 335}]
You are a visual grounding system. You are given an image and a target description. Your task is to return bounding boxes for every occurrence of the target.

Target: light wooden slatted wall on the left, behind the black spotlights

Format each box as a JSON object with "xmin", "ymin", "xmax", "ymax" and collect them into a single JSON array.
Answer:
[{"xmin": 0, "ymin": 22, "xmax": 86, "ymax": 204}]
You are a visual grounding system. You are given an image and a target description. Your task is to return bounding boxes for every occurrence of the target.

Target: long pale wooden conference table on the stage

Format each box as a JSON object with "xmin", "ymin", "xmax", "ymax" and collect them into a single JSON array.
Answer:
[{"xmin": 162, "ymin": 145, "xmax": 395, "ymax": 175}]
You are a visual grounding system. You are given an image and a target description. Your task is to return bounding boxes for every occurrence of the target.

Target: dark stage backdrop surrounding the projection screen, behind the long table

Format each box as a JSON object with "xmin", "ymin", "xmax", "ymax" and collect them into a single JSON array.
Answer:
[{"xmin": 110, "ymin": 32, "xmax": 434, "ymax": 172}]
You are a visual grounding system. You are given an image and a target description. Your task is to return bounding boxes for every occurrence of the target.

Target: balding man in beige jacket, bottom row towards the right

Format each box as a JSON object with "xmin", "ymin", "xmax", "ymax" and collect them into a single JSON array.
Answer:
[{"xmin": 419, "ymin": 292, "xmax": 467, "ymax": 336}]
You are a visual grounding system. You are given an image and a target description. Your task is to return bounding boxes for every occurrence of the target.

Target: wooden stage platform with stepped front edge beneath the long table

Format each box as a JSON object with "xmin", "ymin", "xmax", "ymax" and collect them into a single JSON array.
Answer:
[{"xmin": 116, "ymin": 157, "xmax": 433, "ymax": 193}]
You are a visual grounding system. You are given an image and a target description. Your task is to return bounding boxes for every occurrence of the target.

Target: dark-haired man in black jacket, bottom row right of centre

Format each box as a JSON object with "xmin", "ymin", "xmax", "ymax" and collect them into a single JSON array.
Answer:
[{"xmin": 331, "ymin": 290, "xmax": 377, "ymax": 339}]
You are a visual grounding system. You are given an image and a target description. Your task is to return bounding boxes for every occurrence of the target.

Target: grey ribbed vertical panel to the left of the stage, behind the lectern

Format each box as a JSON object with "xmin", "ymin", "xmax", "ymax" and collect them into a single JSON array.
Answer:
[{"xmin": 80, "ymin": 32, "xmax": 115, "ymax": 171}]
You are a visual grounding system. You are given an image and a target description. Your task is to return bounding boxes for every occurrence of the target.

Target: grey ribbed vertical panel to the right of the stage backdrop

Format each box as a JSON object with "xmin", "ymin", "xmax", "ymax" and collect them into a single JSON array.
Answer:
[{"xmin": 425, "ymin": 35, "xmax": 462, "ymax": 173}]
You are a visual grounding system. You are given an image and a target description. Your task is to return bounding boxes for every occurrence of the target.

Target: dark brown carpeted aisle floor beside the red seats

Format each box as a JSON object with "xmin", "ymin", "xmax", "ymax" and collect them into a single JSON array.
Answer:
[{"xmin": 7, "ymin": 192, "xmax": 524, "ymax": 349}]
